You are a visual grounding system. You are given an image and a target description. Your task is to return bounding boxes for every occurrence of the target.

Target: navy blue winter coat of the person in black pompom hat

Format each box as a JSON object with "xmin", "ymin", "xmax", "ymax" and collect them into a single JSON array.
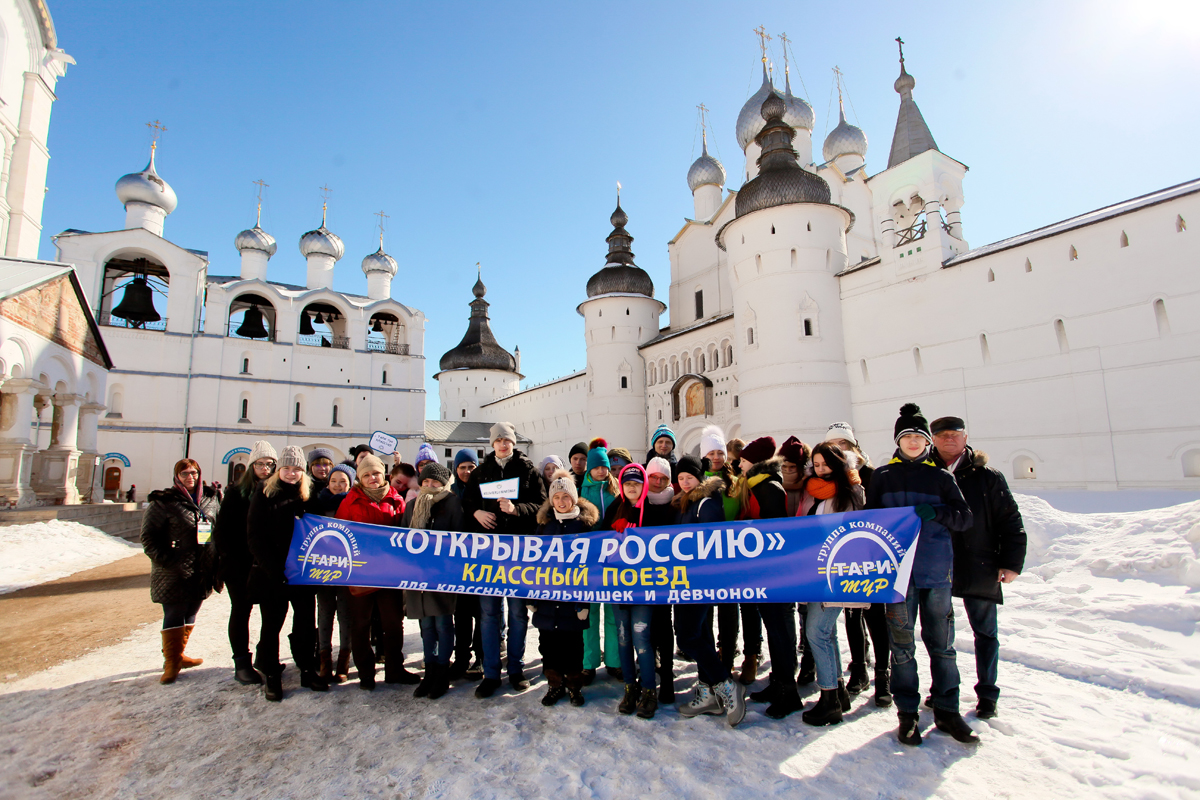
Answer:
[{"xmin": 866, "ymin": 450, "xmax": 972, "ymax": 589}]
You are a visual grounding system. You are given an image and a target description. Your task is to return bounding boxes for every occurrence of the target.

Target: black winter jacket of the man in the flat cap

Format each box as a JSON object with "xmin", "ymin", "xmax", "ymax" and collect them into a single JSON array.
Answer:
[{"xmin": 934, "ymin": 447, "xmax": 1026, "ymax": 603}]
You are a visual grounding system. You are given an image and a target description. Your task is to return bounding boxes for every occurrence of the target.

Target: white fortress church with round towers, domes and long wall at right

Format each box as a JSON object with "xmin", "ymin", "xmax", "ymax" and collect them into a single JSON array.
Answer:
[{"xmin": 438, "ymin": 48, "xmax": 1200, "ymax": 491}]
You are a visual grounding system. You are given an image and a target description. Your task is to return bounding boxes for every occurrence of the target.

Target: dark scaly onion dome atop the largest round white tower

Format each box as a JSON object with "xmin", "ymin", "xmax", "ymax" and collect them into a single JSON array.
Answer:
[{"xmin": 734, "ymin": 91, "xmax": 832, "ymax": 217}]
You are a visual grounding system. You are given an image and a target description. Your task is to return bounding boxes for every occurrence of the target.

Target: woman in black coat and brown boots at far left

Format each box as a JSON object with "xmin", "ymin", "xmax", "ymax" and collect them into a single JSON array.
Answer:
[{"xmin": 142, "ymin": 458, "xmax": 221, "ymax": 684}]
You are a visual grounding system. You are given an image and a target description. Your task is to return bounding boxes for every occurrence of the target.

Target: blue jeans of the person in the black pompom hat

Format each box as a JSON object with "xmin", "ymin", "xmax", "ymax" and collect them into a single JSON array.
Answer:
[{"xmin": 887, "ymin": 583, "xmax": 959, "ymax": 714}]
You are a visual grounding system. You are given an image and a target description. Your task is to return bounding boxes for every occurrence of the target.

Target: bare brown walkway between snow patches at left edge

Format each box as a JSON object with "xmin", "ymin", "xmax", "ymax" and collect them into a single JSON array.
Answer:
[{"xmin": 0, "ymin": 554, "xmax": 162, "ymax": 682}]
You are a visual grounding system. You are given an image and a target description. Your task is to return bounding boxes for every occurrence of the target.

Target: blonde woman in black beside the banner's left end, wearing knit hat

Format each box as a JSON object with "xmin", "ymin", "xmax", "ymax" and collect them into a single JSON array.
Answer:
[{"xmin": 246, "ymin": 445, "xmax": 329, "ymax": 702}]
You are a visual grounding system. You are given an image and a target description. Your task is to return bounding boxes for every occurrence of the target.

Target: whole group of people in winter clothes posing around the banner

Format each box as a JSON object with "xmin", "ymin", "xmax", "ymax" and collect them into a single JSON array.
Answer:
[{"xmin": 142, "ymin": 403, "xmax": 1025, "ymax": 745}]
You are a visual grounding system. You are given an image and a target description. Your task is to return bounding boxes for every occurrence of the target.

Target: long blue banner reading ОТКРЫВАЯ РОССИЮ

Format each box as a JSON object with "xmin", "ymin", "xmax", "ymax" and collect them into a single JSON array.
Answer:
[{"xmin": 286, "ymin": 507, "xmax": 920, "ymax": 604}]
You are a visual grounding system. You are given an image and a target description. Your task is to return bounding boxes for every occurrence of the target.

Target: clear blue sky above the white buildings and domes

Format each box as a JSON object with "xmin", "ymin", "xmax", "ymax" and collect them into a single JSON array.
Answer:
[{"xmin": 41, "ymin": 0, "xmax": 1200, "ymax": 419}]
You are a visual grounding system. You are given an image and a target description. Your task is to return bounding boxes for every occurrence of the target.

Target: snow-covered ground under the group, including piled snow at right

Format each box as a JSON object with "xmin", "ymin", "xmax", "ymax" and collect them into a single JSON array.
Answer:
[{"xmin": 0, "ymin": 497, "xmax": 1200, "ymax": 800}]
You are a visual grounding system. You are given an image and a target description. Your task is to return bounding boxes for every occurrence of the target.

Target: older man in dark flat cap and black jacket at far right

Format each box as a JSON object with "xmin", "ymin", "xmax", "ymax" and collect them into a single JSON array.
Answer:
[{"xmin": 930, "ymin": 416, "xmax": 1026, "ymax": 720}]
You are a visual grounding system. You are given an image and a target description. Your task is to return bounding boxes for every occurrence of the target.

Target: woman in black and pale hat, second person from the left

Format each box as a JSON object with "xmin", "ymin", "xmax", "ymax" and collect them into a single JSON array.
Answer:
[{"xmin": 212, "ymin": 440, "xmax": 278, "ymax": 685}]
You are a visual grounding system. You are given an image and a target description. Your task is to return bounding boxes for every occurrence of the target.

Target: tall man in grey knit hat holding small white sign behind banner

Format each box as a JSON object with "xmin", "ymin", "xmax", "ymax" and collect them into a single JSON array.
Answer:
[{"xmin": 462, "ymin": 422, "xmax": 546, "ymax": 697}]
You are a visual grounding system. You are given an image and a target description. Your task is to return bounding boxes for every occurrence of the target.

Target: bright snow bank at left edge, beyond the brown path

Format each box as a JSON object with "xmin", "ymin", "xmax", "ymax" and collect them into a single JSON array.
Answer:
[{"xmin": 0, "ymin": 519, "xmax": 142, "ymax": 594}]
